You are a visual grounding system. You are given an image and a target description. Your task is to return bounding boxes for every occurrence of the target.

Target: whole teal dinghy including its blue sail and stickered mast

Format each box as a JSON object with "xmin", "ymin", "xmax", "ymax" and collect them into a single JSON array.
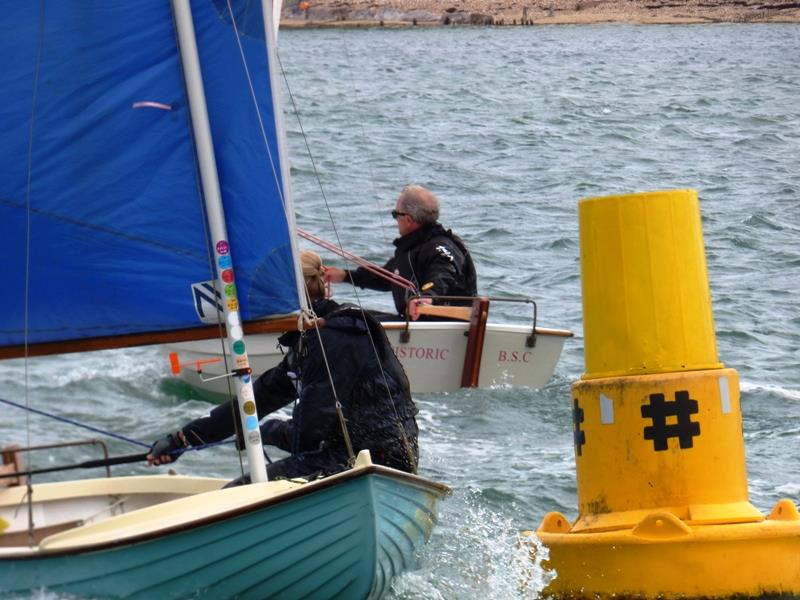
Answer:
[{"xmin": 0, "ymin": 0, "xmax": 448, "ymax": 599}]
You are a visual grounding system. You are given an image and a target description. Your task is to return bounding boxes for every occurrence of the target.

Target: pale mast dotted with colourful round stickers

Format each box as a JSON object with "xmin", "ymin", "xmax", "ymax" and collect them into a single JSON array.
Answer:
[{"xmin": 172, "ymin": 0, "xmax": 267, "ymax": 483}]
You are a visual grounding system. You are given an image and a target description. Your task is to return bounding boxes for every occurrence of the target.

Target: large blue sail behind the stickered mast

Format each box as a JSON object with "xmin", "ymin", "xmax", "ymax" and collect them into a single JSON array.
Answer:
[{"xmin": 0, "ymin": 0, "xmax": 300, "ymax": 346}]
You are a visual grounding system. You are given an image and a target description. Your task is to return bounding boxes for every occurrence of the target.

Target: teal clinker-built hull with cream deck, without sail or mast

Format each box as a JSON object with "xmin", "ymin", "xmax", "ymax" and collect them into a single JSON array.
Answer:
[{"xmin": 0, "ymin": 451, "xmax": 447, "ymax": 599}]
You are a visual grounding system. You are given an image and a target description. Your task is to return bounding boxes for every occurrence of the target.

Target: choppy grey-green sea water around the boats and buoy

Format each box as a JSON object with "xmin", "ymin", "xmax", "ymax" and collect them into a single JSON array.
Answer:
[{"xmin": 0, "ymin": 25, "xmax": 800, "ymax": 599}]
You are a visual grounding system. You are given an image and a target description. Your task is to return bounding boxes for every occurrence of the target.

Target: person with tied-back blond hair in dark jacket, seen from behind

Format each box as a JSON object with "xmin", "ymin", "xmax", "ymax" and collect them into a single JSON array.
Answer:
[{"xmin": 147, "ymin": 252, "xmax": 419, "ymax": 479}]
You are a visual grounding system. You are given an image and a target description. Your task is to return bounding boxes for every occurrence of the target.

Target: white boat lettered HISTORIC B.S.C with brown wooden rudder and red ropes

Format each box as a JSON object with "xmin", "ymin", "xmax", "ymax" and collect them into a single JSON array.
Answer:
[{"xmin": 163, "ymin": 28, "xmax": 573, "ymax": 402}]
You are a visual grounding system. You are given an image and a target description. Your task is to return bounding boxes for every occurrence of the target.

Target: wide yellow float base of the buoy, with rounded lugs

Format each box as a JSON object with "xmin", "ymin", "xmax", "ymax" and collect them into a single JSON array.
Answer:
[{"xmin": 523, "ymin": 500, "xmax": 800, "ymax": 600}]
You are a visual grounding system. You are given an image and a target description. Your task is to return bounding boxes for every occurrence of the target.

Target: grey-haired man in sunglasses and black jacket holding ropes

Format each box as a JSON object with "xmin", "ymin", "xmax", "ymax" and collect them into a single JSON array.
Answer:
[{"xmin": 325, "ymin": 185, "xmax": 478, "ymax": 319}]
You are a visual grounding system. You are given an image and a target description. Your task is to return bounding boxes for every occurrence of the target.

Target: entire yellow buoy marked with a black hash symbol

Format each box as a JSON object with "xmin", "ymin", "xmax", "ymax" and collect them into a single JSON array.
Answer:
[{"xmin": 526, "ymin": 190, "xmax": 800, "ymax": 598}]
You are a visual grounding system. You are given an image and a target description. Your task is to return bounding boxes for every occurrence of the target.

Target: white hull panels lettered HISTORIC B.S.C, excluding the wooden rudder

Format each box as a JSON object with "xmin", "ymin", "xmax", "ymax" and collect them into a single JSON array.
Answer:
[{"xmin": 165, "ymin": 322, "xmax": 572, "ymax": 400}]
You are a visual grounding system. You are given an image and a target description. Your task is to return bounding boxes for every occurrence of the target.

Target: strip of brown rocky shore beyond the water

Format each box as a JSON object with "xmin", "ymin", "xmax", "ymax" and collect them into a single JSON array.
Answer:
[{"xmin": 281, "ymin": 0, "xmax": 800, "ymax": 28}]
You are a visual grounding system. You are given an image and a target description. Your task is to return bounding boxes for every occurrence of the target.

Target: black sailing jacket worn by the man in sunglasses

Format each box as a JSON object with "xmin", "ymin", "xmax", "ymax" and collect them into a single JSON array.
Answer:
[{"xmin": 345, "ymin": 223, "xmax": 478, "ymax": 316}]
